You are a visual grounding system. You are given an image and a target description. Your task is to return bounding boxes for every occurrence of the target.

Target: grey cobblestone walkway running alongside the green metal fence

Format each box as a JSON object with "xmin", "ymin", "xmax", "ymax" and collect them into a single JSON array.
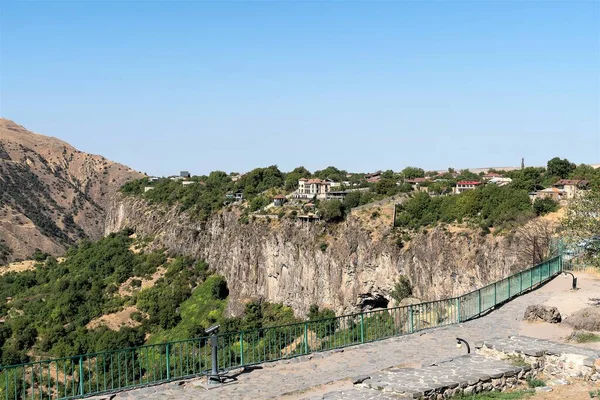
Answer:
[{"xmin": 91, "ymin": 274, "xmax": 599, "ymax": 400}]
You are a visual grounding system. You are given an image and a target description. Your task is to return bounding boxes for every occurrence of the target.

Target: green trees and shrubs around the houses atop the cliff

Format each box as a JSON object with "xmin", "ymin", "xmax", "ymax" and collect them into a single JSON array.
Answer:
[{"xmin": 121, "ymin": 157, "xmax": 600, "ymax": 228}]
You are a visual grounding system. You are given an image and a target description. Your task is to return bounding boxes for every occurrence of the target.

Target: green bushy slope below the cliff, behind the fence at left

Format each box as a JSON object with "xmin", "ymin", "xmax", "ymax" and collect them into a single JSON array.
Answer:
[{"xmin": 0, "ymin": 231, "xmax": 312, "ymax": 365}]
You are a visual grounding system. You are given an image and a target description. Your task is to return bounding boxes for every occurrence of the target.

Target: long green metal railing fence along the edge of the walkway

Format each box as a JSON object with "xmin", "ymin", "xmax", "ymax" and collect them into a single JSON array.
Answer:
[{"xmin": 0, "ymin": 256, "xmax": 563, "ymax": 400}]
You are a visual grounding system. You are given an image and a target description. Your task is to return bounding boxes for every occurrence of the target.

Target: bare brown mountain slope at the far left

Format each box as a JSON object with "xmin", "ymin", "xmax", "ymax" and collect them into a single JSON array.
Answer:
[{"xmin": 0, "ymin": 118, "xmax": 144, "ymax": 264}]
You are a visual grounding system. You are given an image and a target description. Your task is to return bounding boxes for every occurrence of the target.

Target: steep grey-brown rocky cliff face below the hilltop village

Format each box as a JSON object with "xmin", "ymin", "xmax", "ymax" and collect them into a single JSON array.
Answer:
[{"xmin": 106, "ymin": 196, "xmax": 520, "ymax": 316}]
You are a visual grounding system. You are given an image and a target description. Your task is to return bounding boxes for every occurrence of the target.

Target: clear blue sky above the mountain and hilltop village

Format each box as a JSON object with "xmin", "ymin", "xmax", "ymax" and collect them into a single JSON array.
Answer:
[{"xmin": 0, "ymin": 0, "xmax": 600, "ymax": 175}]
